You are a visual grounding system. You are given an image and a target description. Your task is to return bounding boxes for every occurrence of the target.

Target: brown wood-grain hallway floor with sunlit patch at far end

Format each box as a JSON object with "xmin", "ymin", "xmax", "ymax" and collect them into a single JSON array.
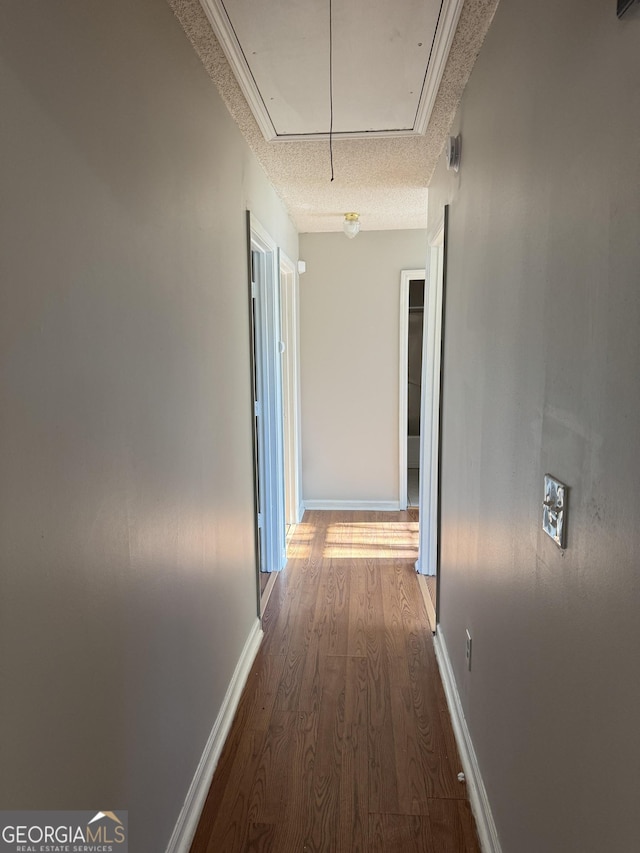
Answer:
[{"xmin": 191, "ymin": 510, "xmax": 480, "ymax": 853}]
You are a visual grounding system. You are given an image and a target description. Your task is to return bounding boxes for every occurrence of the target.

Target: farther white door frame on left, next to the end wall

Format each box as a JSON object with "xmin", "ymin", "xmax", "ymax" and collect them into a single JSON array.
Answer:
[{"xmin": 280, "ymin": 251, "xmax": 304, "ymax": 524}]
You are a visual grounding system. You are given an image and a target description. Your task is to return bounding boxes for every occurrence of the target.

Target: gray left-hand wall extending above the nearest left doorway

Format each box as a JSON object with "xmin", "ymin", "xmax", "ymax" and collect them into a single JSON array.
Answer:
[{"xmin": 0, "ymin": 0, "xmax": 297, "ymax": 853}]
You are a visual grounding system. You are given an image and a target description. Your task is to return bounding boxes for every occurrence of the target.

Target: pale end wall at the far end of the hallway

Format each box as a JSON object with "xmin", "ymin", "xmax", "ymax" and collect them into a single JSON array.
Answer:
[{"xmin": 300, "ymin": 230, "xmax": 427, "ymax": 505}]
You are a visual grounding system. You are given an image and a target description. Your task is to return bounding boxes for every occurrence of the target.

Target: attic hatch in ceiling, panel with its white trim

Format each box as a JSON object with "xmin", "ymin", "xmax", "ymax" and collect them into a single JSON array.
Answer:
[{"xmin": 201, "ymin": 0, "xmax": 462, "ymax": 140}]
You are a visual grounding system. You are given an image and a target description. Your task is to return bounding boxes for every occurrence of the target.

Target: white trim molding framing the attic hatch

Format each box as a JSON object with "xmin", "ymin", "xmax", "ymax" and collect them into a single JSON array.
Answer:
[{"xmin": 200, "ymin": 0, "xmax": 464, "ymax": 142}]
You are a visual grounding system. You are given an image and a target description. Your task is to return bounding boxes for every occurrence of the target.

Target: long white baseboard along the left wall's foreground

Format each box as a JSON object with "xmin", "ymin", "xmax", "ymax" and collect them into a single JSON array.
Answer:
[{"xmin": 166, "ymin": 619, "xmax": 262, "ymax": 853}]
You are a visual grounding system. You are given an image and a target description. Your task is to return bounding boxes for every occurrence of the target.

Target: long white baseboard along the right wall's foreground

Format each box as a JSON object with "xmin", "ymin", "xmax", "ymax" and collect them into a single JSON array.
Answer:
[{"xmin": 433, "ymin": 627, "xmax": 502, "ymax": 853}]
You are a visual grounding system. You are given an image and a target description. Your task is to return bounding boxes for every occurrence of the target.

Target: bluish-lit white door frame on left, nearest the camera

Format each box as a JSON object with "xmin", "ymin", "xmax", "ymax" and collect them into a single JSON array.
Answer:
[{"xmin": 249, "ymin": 214, "xmax": 286, "ymax": 572}]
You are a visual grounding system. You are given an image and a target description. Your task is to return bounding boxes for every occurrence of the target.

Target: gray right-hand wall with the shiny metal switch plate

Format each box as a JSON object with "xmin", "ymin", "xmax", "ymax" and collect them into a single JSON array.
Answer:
[{"xmin": 429, "ymin": 0, "xmax": 640, "ymax": 853}]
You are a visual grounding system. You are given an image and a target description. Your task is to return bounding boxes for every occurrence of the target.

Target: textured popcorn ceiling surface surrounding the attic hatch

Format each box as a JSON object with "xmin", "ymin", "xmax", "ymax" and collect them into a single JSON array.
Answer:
[{"xmin": 168, "ymin": 0, "xmax": 499, "ymax": 233}]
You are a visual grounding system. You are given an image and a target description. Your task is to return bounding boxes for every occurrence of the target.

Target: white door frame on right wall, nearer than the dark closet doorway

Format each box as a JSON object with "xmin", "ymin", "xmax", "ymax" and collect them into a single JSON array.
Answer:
[{"xmin": 416, "ymin": 219, "xmax": 445, "ymax": 575}]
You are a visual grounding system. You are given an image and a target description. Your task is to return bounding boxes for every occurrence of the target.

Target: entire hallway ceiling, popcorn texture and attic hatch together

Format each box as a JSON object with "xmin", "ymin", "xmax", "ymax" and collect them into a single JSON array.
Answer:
[{"xmin": 168, "ymin": 0, "xmax": 498, "ymax": 232}]
